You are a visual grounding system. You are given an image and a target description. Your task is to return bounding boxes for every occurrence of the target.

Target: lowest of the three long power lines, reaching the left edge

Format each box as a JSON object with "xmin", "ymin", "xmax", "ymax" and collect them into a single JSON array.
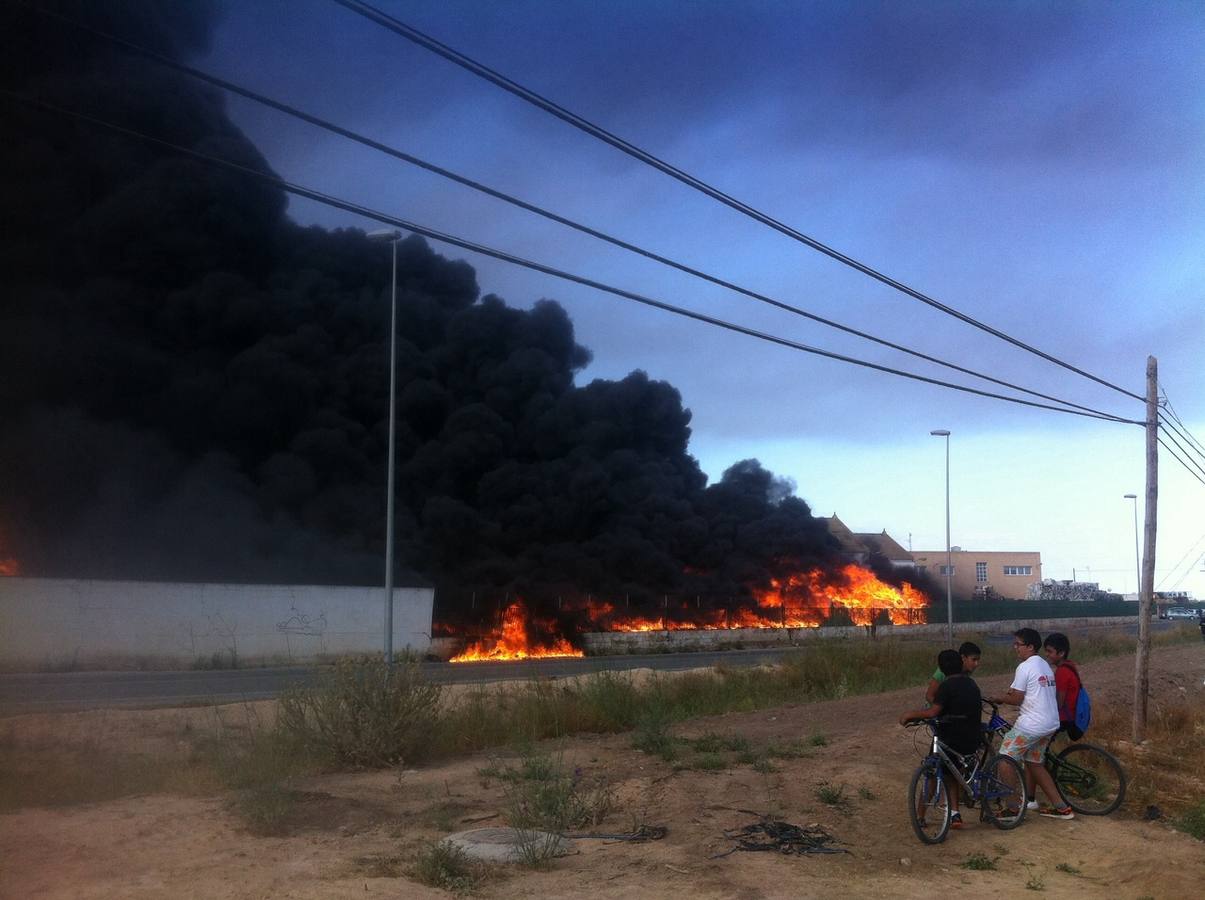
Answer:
[{"xmin": 0, "ymin": 89, "xmax": 1144, "ymax": 425}]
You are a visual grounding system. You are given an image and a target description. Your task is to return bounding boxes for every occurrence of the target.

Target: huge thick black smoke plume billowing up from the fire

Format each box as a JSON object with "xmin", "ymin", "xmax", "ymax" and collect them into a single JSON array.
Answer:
[{"xmin": 0, "ymin": 0, "xmax": 886, "ymax": 622}]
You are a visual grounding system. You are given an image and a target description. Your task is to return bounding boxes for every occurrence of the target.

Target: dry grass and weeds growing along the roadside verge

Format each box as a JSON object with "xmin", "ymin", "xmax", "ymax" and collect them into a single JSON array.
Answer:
[{"xmin": 0, "ymin": 635, "xmax": 1205, "ymax": 820}]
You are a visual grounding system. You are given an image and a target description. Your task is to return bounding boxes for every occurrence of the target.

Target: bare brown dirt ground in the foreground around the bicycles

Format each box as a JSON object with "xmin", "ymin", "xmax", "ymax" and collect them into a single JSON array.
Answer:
[{"xmin": 0, "ymin": 645, "xmax": 1205, "ymax": 900}]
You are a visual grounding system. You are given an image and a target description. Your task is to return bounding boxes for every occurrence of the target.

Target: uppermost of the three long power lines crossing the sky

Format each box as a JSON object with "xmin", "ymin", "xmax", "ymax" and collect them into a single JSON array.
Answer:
[{"xmin": 334, "ymin": 0, "xmax": 1145, "ymax": 400}]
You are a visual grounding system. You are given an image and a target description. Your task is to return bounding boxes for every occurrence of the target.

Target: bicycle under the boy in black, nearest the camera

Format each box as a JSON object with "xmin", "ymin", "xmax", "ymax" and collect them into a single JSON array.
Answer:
[{"xmin": 909, "ymin": 716, "xmax": 1025, "ymax": 843}]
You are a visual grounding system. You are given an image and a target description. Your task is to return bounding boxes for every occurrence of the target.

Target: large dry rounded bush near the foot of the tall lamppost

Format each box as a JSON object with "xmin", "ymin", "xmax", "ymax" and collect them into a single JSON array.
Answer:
[{"xmin": 277, "ymin": 654, "xmax": 440, "ymax": 767}]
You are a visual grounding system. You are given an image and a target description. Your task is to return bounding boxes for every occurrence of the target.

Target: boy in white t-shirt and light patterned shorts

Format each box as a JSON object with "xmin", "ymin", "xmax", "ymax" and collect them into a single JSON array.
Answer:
[{"xmin": 994, "ymin": 628, "xmax": 1075, "ymax": 819}]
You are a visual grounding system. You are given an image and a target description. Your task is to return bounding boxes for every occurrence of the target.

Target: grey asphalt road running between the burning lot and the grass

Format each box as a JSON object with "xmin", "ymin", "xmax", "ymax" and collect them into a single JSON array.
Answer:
[{"xmin": 0, "ymin": 620, "xmax": 1175, "ymax": 716}]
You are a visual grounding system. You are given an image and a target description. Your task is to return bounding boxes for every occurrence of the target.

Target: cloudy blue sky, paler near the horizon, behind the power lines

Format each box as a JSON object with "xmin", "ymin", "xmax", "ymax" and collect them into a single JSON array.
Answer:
[{"xmin": 198, "ymin": 0, "xmax": 1205, "ymax": 598}]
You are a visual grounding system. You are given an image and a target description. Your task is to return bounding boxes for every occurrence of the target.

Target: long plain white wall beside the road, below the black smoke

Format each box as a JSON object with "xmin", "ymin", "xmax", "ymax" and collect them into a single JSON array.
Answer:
[{"xmin": 0, "ymin": 577, "xmax": 435, "ymax": 670}]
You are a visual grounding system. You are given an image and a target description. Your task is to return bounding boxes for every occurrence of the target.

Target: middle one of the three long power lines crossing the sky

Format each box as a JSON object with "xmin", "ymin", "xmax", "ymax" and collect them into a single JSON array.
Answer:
[{"xmin": 18, "ymin": 0, "xmax": 1125, "ymax": 422}]
